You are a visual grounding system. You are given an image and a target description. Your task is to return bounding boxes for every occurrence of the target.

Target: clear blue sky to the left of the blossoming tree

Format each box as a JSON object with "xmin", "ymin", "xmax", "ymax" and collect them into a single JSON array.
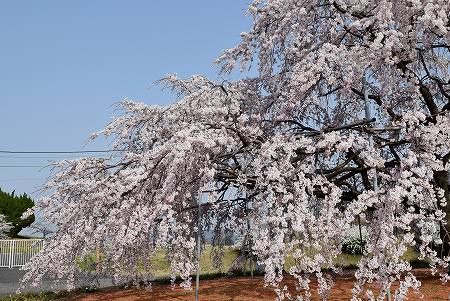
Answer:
[{"xmin": 0, "ymin": 0, "xmax": 251, "ymax": 198}]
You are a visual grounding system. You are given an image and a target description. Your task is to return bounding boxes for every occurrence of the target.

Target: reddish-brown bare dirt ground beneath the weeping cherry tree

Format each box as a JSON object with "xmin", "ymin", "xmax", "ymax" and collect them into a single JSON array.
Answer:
[{"xmin": 70, "ymin": 270, "xmax": 450, "ymax": 301}]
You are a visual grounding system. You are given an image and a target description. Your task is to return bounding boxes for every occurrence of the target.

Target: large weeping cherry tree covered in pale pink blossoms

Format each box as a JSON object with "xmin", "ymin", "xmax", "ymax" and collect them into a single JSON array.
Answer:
[{"xmin": 24, "ymin": 0, "xmax": 450, "ymax": 300}]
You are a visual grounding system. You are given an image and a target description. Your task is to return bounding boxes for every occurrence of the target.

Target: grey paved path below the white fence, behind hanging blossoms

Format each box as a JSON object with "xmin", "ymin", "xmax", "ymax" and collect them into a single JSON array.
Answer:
[{"xmin": 0, "ymin": 268, "xmax": 112, "ymax": 296}]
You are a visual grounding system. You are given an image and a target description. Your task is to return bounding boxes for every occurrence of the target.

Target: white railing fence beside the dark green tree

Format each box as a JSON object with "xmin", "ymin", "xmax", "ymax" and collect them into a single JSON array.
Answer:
[{"xmin": 0, "ymin": 239, "xmax": 44, "ymax": 268}]
